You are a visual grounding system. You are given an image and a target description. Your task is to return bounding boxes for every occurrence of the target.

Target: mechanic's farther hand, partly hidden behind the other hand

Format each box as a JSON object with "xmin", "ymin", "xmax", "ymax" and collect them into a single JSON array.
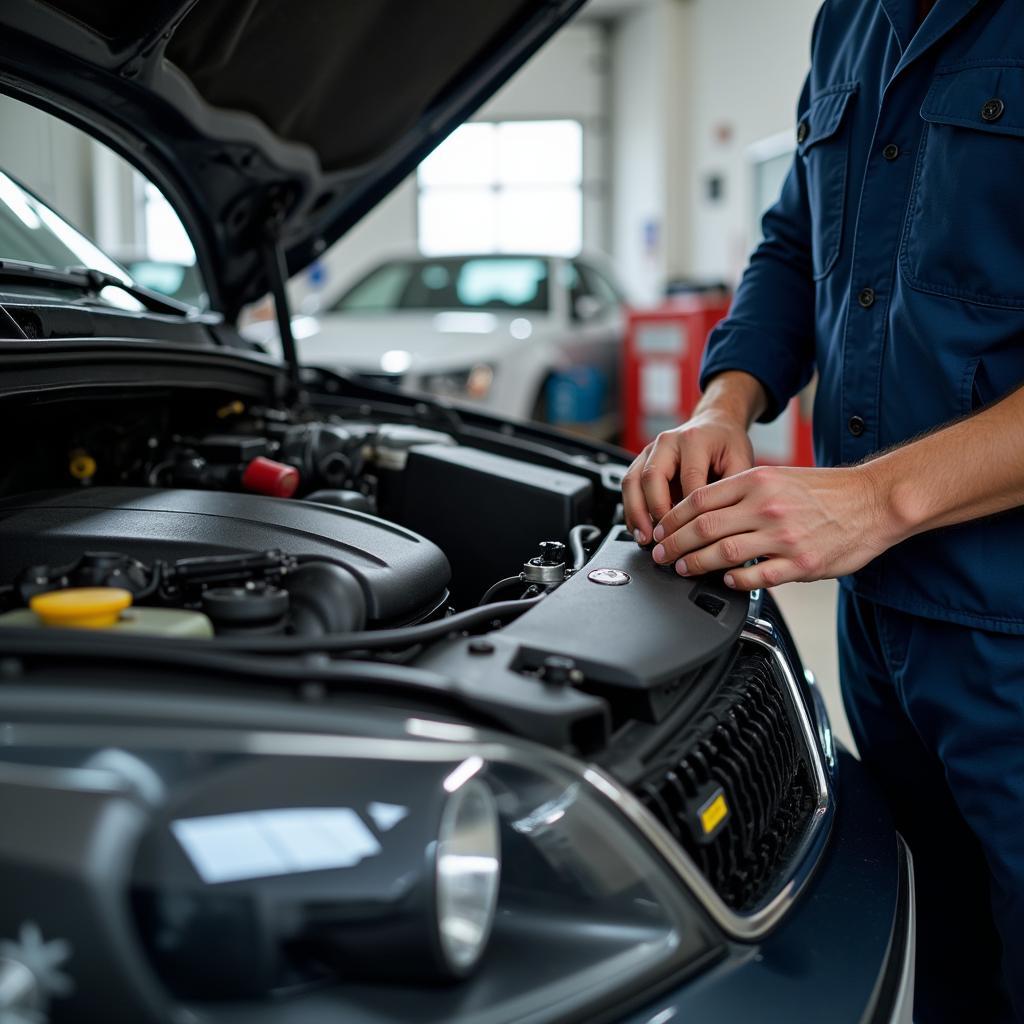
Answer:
[{"xmin": 623, "ymin": 408, "xmax": 754, "ymax": 544}]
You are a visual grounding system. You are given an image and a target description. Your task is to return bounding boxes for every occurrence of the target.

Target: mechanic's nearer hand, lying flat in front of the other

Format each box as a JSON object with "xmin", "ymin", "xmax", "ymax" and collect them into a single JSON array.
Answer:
[{"xmin": 653, "ymin": 466, "xmax": 901, "ymax": 590}]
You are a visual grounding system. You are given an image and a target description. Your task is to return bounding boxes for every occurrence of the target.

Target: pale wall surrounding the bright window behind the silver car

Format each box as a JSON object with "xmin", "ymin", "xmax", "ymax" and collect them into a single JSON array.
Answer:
[{"xmin": 293, "ymin": 23, "xmax": 609, "ymax": 303}]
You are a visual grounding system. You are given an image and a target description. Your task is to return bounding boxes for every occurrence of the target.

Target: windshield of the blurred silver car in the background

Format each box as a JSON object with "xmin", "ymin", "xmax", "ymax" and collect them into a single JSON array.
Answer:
[{"xmin": 331, "ymin": 256, "xmax": 550, "ymax": 312}]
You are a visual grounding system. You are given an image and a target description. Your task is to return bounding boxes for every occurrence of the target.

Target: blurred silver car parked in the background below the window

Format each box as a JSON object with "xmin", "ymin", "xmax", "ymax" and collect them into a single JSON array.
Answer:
[{"xmin": 244, "ymin": 253, "xmax": 626, "ymax": 438}]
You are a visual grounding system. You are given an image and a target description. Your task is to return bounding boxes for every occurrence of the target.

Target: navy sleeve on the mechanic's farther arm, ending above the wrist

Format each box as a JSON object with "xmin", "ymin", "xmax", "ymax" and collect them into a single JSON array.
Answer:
[{"xmin": 700, "ymin": 79, "xmax": 814, "ymax": 423}]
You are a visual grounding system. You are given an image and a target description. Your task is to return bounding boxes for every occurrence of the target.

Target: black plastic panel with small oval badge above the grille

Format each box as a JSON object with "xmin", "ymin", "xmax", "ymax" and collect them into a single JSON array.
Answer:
[{"xmin": 416, "ymin": 528, "xmax": 749, "ymax": 753}]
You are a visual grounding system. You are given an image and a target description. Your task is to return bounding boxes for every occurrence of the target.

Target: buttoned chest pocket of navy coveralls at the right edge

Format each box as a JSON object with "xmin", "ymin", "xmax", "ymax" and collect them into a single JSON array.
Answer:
[{"xmin": 900, "ymin": 64, "xmax": 1024, "ymax": 308}]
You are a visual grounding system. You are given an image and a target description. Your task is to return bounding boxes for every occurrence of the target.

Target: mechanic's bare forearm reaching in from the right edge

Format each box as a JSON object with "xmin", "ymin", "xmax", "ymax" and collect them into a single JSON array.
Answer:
[{"xmin": 858, "ymin": 388, "xmax": 1024, "ymax": 544}]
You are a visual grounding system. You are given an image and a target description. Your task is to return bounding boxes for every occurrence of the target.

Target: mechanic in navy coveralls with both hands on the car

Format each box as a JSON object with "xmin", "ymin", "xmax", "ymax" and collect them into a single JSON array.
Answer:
[{"xmin": 623, "ymin": 0, "xmax": 1024, "ymax": 1024}]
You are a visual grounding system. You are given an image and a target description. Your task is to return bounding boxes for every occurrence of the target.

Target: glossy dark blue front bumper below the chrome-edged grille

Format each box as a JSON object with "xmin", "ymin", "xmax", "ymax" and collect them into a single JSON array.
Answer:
[{"xmin": 621, "ymin": 750, "xmax": 915, "ymax": 1024}]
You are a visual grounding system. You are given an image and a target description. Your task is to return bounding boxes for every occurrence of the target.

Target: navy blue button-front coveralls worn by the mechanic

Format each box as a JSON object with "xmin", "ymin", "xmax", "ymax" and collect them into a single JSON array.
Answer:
[{"xmin": 701, "ymin": 0, "xmax": 1024, "ymax": 1011}]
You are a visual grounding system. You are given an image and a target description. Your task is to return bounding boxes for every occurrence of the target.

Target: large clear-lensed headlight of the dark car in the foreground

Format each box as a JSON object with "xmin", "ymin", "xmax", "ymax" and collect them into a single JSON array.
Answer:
[{"xmin": 3, "ymin": 718, "xmax": 720, "ymax": 1024}]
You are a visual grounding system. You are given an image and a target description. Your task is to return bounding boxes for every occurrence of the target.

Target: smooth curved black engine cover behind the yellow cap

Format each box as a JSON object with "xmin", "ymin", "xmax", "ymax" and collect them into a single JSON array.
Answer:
[{"xmin": 0, "ymin": 487, "xmax": 451, "ymax": 626}]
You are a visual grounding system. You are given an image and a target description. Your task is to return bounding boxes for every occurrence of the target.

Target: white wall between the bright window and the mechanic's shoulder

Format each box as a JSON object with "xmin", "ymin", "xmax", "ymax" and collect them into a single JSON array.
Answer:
[{"xmin": 611, "ymin": 0, "xmax": 820, "ymax": 302}]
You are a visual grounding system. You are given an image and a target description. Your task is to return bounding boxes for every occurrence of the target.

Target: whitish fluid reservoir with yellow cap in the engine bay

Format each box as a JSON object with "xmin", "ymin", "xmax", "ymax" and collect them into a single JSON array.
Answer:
[{"xmin": 0, "ymin": 587, "xmax": 213, "ymax": 637}]
